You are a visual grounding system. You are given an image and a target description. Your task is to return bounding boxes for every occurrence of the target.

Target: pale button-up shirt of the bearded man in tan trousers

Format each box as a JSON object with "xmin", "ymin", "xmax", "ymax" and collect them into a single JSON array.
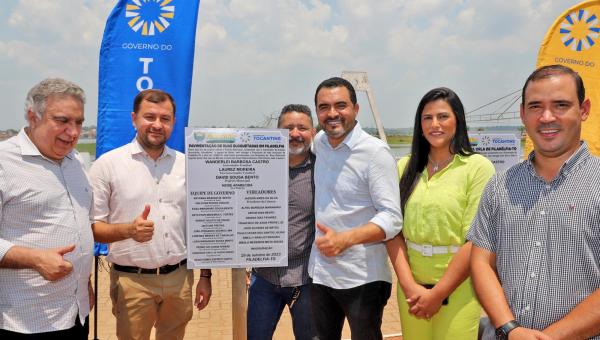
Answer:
[{"xmin": 90, "ymin": 139, "xmax": 187, "ymax": 268}]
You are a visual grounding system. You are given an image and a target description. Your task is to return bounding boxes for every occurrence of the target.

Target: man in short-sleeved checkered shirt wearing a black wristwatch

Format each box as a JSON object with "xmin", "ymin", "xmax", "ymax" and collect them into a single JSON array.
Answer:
[{"xmin": 467, "ymin": 65, "xmax": 600, "ymax": 340}]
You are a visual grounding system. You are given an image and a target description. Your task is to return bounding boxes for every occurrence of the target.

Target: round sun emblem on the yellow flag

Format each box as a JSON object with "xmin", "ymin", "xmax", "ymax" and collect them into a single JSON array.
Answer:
[{"xmin": 560, "ymin": 9, "xmax": 600, "ymax": 52}]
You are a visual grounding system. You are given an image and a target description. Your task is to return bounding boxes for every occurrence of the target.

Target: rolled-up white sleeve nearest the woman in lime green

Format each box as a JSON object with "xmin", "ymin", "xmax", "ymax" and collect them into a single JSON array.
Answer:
[{"xmin": 368, "ymin": 148, "xmax": 402, "ymax": 241}]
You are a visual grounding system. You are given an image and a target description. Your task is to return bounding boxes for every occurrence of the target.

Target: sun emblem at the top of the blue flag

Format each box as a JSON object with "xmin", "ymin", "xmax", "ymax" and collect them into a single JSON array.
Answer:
[{"xmin": 125, "ymin": 0, "xmax": 175, "ymax": 35}]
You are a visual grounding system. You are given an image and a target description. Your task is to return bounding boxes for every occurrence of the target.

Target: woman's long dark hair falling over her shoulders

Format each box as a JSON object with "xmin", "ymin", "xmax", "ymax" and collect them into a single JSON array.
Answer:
[{"xmin": 400, "ymin": 87, "xmax": 474, "ymax": 213}]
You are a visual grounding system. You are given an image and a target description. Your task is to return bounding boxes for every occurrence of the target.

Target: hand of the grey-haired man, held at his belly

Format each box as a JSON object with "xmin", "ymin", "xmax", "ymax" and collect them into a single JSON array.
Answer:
[{"xmin": 33, "ymin": 244, "xmax": 75, "ymax": 281}]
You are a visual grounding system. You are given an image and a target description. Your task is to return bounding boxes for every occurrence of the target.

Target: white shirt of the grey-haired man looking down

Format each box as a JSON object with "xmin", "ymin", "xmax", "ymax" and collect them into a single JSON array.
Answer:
[{"xmin": 0, "ymin": 129, "xmax": 94, "ymax": 333}]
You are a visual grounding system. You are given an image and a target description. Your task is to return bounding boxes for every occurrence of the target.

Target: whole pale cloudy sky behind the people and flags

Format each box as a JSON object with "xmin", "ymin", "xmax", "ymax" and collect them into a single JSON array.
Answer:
[{"xmin": 0, "ymin": 0, "xmax": 577, "ymax": 130}]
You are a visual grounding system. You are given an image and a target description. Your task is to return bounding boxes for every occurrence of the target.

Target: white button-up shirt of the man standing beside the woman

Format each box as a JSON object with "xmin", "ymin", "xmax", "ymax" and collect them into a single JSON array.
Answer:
[{"xmin": 309, "ymin": 122, "xmax": 402, "ymax": 289}]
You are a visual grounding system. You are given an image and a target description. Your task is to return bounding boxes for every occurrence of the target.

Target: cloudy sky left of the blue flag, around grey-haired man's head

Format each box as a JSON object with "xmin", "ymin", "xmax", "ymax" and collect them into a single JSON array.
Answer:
[{"xmin": 0, "ymin": 0, "xmax": 115, "ymax": 128}]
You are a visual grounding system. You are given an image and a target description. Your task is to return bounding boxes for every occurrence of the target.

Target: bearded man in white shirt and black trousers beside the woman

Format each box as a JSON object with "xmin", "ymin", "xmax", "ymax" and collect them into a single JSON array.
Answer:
[{"xmin": 309, "ymin": 78, "xmax": 402, "ymax": 340}]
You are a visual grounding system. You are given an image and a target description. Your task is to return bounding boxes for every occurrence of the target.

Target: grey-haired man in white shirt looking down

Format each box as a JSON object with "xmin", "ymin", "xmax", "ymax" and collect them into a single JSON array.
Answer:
[{"xmin": 0, "ymin": 78, "xmax": 94, "ymax": 340}]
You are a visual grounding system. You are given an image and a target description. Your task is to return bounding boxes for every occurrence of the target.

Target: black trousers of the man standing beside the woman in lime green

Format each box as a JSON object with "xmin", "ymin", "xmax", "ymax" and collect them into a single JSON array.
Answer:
[{"xmin": 311, "ymin": 281, "xmax": 392, "ymax": 340}]
